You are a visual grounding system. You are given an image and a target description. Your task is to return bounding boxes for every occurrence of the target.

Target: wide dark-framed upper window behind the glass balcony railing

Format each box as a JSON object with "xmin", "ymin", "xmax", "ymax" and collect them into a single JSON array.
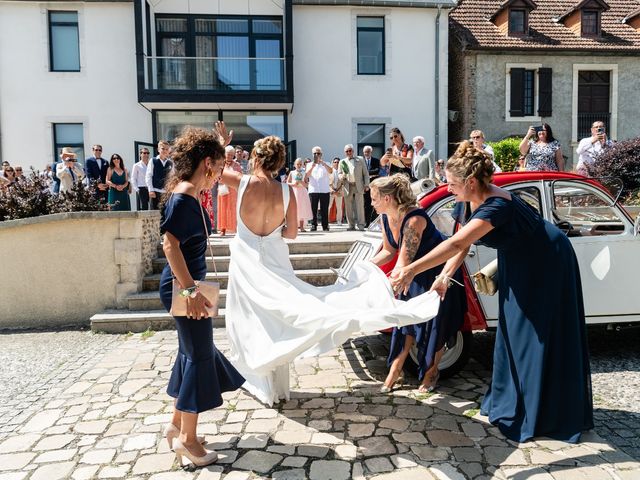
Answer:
[{"xmin": 152, "ymin": 15, "xmax": 285, "ymax": 91}]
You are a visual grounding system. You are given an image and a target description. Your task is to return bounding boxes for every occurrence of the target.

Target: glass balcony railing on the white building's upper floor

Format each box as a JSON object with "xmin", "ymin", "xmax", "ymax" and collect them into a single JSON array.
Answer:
[{"xmin": 145, "ymin": 57, "xmax": 286, "ymax": 93}]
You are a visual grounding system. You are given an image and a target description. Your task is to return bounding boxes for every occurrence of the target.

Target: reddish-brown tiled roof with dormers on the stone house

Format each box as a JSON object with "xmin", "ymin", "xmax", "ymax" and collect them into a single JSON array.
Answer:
[{"xmin": 449, "ymin": 0, "xmax": 640, "ymax": 52}]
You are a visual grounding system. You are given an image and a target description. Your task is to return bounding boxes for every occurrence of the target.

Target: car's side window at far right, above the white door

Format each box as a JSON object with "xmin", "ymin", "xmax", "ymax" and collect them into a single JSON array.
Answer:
[{"xmin": 553, "ymin": 182, "xmax": 625, "ymax": 237}]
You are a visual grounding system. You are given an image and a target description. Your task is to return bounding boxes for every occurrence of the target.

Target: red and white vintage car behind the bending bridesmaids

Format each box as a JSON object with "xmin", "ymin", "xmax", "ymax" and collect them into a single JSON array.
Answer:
[{"xmin": 339, "ymin": 172, "xmax": 640, "ymax": 376}]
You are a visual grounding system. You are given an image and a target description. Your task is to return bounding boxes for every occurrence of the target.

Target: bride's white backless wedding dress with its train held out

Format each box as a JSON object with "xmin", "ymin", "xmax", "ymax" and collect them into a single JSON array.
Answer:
[{"xmin": 225, "ymin": 175, "xmax": 440, "ymax": 405}]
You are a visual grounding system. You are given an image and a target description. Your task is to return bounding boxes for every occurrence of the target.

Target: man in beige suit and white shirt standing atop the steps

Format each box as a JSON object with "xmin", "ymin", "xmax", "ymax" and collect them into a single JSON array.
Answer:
[{"xmin": 340, "ymin": 145, "xmax": 369, "ymax": 230}]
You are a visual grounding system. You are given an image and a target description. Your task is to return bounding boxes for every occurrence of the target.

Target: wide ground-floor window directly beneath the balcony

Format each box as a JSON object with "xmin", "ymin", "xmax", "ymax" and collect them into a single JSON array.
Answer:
[{"xmin": 155, "ymin": 110, "xmax": 287, "ymax": 151}]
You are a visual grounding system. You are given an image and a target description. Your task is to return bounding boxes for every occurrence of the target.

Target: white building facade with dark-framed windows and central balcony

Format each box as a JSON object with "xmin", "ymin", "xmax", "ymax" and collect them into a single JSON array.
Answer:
[{"xmin": 0, "ymin": 0, "xmax": 454, "ymax": 169}]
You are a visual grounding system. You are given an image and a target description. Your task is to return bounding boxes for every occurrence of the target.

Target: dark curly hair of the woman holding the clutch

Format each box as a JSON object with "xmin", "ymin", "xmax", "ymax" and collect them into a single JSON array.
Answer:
[{"xmin": 163, "ymin": 127, "xmax": 224, "ymax": 201}]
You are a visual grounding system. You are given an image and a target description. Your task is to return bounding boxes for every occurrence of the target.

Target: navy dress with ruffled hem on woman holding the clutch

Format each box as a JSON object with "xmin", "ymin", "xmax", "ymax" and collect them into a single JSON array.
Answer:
[{"xmin": 160, "ymin": 193, "xmax": 244, "ymax": 413}]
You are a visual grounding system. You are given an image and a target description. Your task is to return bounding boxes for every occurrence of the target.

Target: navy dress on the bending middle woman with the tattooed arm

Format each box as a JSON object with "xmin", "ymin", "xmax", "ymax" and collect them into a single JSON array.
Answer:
[{"xmin": 382, "ymin": 209, "xmax": 467, "ymax": 380}]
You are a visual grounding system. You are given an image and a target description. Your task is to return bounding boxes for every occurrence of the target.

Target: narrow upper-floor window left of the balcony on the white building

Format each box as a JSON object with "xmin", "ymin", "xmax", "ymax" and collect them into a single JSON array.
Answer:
[{"xmin": 49, "ymin": 11, "xmax": 80, "ymax": 72}]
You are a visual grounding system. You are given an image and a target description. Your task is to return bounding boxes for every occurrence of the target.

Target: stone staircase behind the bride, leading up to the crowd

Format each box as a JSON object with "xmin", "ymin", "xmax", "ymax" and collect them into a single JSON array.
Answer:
[{"xmin": 91, "ymin": 232, "xmax": 357, "ymax": 333}]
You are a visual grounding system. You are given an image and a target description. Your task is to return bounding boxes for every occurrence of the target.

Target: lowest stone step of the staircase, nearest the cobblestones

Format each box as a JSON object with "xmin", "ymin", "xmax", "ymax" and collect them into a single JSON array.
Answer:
[{"xmin": 91, "ymin": 309, "xmax": 224, "ymax": 333}]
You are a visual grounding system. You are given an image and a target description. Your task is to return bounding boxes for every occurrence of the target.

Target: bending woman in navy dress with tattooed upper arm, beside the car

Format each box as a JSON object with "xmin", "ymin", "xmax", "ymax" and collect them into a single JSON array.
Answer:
[{"xmin": 371, "ymin": 173, "xmax": 466, "ymax": 393}]
